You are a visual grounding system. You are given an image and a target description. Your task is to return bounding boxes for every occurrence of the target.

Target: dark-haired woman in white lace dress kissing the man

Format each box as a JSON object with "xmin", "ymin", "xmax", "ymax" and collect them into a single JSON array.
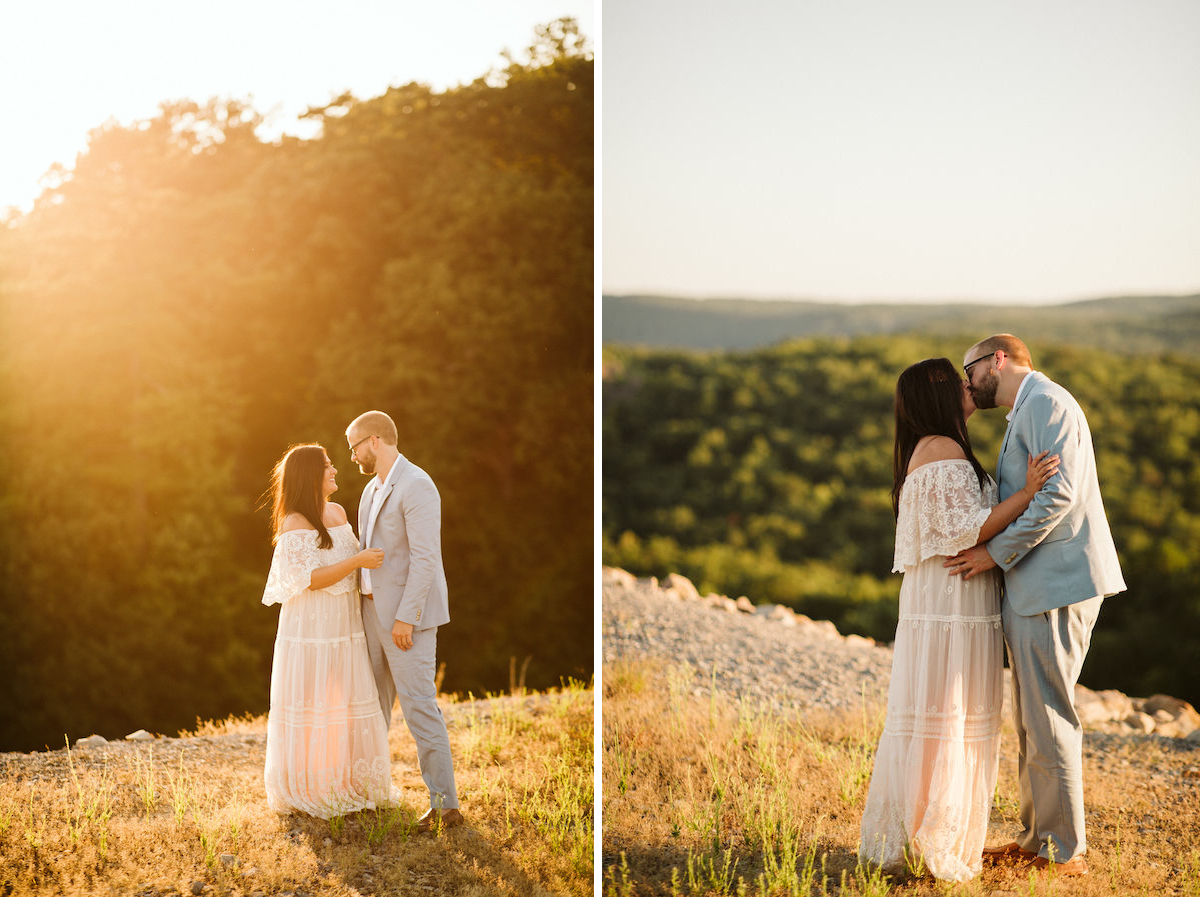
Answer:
[{"xmin": 859, "ymin": 359, "xmax": 1058, "ymax": 881}]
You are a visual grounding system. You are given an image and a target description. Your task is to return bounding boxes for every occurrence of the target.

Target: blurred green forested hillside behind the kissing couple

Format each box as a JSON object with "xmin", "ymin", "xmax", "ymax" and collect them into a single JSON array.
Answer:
[{"xmin": 602, "ymin": 333, "xmax": 1200, "ymax": 703}]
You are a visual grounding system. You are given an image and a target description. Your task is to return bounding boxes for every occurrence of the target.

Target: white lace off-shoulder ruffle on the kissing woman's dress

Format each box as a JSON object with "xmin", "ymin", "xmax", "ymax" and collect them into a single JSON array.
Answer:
[{"xmin": 892, "ymin": 460, "xmax": 994, "ymax": 573}]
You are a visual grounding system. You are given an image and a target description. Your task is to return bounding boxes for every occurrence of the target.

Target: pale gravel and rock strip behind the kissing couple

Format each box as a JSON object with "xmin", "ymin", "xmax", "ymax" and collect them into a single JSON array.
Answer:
[{"xmin": 602, "ymin": 567, "xmax": 1200, "ymax": 742}]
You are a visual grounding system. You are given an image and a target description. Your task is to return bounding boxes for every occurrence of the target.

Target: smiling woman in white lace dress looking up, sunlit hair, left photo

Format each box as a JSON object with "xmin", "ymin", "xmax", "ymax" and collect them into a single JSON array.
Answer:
[{"xmin": 263, "ymin": 445, "xmax": 392, "ymax": 819}]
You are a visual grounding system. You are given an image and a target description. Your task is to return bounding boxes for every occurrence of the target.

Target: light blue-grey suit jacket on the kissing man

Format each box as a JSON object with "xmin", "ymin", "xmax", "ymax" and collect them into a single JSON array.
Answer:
[{"xmin": 986, "ymin": 371, "xmax": 1126, "ymax": 616}]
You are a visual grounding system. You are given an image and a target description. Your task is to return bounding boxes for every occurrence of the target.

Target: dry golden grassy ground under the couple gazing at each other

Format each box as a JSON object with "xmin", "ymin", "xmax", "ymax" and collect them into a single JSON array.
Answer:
[{"xmin": 0, "ymin": 682, "xmax": 594, "ymax": 897}]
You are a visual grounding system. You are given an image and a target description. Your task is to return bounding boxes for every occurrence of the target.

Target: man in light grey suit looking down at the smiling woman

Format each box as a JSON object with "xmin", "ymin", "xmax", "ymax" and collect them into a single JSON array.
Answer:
[{"xmin": 346, "ymin": 411, "xmax": 463, "ymax": 831}]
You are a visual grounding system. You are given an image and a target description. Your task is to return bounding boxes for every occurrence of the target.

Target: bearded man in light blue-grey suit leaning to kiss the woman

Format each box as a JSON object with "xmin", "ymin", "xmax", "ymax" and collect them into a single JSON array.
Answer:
[{"xmin": 946, "ymin": 333, "xmax": 1126, "ymax": 875}]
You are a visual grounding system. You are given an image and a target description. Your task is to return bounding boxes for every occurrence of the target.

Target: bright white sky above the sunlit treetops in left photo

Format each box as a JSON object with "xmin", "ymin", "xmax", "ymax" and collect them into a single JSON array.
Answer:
[{"xmin": 0, "ymin": 0, "xmax": 596, "ymax": 212}]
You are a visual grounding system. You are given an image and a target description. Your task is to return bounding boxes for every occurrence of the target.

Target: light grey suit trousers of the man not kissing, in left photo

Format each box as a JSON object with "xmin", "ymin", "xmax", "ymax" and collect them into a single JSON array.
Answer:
[{"xmin": 362, "ymin": 598, "xmax": 458, "ymax": 809}]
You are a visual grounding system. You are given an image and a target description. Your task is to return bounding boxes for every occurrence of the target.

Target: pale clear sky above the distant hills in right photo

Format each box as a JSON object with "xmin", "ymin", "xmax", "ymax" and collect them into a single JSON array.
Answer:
[{"xmin": 602, "ymin": 0, "xmax": 1200, "ymax": 302}]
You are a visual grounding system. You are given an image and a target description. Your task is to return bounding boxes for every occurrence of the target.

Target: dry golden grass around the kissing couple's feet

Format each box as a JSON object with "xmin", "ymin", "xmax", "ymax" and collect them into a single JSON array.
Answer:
[{"xmin": 602, "ymin": 664, "xmax": 1200, "ymax": 897}]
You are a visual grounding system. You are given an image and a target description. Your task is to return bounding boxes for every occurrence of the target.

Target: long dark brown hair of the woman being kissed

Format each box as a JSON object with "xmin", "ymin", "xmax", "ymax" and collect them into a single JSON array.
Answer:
[{"xmin": 892, "ymin": 359, "xmax": 988, "ymax": 518}]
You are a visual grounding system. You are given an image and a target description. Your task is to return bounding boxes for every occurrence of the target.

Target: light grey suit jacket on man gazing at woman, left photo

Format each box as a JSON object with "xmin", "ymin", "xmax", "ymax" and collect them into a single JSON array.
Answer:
[{"xmin": 359, "ymin": 454, "xmax": 450, "ymax": 633}]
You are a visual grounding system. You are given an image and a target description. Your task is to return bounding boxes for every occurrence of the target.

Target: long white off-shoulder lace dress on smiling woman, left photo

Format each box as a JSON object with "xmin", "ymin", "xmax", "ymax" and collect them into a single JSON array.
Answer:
[{"xmin": 263, "ymin": 523, "xmax": 392, "ymax": 819}]
